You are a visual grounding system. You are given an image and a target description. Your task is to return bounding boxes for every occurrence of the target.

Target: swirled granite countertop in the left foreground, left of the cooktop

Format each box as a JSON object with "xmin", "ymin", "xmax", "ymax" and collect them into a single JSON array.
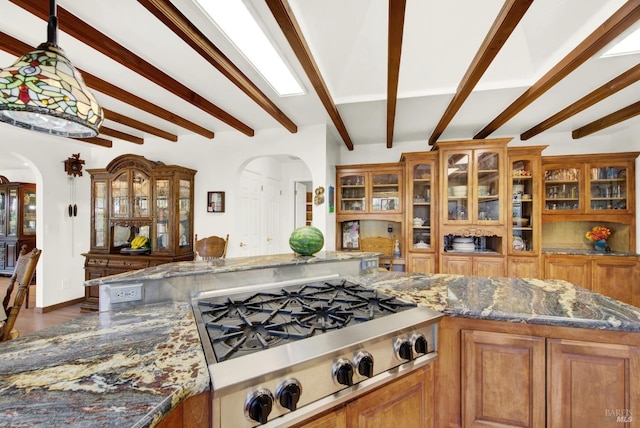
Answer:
[{"xmin": 0, "ymin": 302, "xmax": 210, "ymax": 427}]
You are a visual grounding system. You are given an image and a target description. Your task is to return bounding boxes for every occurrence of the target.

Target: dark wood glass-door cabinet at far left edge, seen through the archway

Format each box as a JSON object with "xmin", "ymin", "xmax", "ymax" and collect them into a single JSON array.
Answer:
[{"xmin": 0, "ymin": 175, "xmax": 36, "ymax": 275}]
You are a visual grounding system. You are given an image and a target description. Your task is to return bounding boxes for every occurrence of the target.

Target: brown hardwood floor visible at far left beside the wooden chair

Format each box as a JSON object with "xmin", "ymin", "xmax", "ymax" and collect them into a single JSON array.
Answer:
[{"xmin": 0, "ymin": 276, "xmax": 83, "ymax": 335}]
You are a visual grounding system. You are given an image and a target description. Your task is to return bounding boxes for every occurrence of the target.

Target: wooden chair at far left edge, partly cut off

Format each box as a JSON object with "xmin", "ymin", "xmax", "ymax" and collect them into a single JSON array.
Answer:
[{"xmin": 0, "ymin": 245, "xmax": 42, "ymax": 342}]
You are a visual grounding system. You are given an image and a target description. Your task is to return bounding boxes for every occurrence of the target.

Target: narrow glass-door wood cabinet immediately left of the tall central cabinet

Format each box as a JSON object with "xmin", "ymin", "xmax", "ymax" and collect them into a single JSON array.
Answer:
[{"xmin": 401, "ymin": 152, "xmax": 439, "ymax": 273}]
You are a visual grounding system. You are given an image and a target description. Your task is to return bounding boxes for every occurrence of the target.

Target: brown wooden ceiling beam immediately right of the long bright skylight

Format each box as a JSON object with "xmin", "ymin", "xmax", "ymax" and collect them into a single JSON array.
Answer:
[{"xmin": 265, "ymin": 0, "xmax": 353, "ymax": 150}]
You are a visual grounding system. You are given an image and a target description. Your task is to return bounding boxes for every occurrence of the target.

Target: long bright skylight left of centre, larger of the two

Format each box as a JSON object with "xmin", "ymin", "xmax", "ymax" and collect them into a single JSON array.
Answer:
[{"xmin": 194, "ymin": 0, "xmax": 304, "ymax": 97}]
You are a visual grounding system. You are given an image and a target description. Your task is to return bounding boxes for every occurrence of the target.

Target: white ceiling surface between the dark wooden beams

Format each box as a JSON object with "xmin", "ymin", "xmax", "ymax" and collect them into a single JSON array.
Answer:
[{"xmin": 0, "ymin": 0, "xmax": 640, "ymax": 164}]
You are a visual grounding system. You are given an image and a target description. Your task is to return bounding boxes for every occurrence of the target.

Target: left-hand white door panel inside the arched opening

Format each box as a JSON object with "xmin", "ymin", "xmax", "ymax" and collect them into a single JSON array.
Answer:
[{"xmin": 236, "ymin": 171, "xmax": 261, "ymax": 257}]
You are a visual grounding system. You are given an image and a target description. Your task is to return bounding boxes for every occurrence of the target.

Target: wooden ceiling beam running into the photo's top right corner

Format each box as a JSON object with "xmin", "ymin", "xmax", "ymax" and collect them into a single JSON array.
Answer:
[{"xmin": 473, "ymin": 0, "xmax": 640, "ymax": 139}]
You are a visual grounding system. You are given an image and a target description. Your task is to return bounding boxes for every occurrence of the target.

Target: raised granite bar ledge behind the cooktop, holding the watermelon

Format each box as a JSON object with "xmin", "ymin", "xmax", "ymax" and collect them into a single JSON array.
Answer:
[{"xmin": 84, "ymin": 251, "xmax": 380, "ymax": 286}]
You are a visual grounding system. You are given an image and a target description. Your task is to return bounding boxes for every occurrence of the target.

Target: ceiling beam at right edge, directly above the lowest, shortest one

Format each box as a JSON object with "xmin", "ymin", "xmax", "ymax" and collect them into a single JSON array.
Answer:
[{"xmin": 520, "ymin": 64, "xmax": 640, "ymax": 141}]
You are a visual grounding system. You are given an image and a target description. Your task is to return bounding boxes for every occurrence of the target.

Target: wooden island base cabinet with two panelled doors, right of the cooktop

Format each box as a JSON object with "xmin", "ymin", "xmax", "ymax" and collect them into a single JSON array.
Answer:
[{"xmin": 435, "ymin": 317, "xmax": 640, "ymax": 428}]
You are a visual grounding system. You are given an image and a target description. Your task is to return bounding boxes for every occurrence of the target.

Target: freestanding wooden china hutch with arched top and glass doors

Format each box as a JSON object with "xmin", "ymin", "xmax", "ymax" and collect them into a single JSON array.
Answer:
[{"xmin": 81, "ymin": 154, "xmax": 196, "ymax": 312}]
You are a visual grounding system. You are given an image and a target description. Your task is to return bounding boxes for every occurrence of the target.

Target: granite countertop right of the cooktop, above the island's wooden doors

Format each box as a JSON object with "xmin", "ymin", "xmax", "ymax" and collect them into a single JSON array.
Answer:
[{"xmin": 354, "ymin": 272, "xmax": 640, "ymax": 332}]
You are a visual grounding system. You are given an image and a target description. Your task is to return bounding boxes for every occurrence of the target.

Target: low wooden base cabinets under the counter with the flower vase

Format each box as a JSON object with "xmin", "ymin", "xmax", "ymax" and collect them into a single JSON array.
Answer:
[{"xmin": 544, "ymin": 254, "xmax": 640, "ymax": 307}]
